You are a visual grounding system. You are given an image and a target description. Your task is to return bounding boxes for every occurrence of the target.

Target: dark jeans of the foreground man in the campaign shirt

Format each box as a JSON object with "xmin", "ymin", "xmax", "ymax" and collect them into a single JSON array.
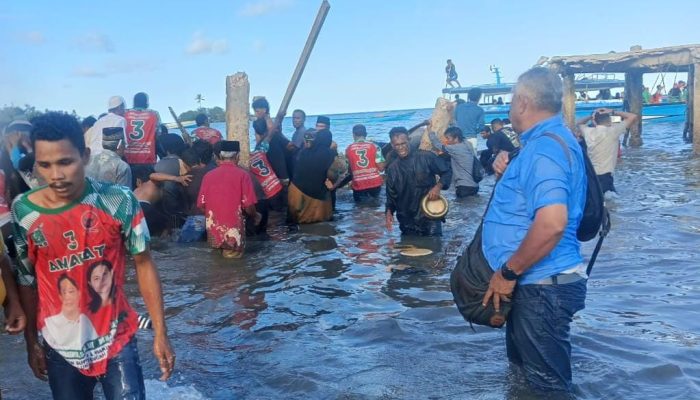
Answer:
[{"xmin": 46, "ymin": 337, "xmax": 146, "ymax": 400}]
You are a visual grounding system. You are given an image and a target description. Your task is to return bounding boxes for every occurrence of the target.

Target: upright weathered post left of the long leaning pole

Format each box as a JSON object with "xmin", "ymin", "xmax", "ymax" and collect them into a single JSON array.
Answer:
[{"xmin": 226, "ymin": 72, "xmax": 250, "ymax": 166}]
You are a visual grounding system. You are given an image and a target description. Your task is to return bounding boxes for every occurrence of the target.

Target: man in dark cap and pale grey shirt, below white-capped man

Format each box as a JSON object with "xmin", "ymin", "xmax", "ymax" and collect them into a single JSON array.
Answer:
[{"xmin": 85, "ymin": 128, "xmax": 132, "ymax": 188}]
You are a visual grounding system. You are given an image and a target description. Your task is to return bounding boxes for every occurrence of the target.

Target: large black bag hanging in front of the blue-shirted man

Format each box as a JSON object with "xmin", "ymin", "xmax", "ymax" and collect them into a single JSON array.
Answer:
[{"xmin": 450, "ymin": 223, "xmax": 511, "ymax": 328}]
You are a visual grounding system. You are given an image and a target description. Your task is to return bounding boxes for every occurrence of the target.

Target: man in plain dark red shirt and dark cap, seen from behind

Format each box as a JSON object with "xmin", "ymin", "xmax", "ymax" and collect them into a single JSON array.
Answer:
[{"xmin": 197, "ymin": 140, "xmax": 259, "ymax": 258}]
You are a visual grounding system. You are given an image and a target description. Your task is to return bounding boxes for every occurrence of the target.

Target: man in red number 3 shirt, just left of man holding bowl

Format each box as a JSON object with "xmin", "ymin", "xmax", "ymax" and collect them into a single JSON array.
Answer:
[{"xmin": 345, "ymin": 124, "xmax": 384, "ymax": 202}]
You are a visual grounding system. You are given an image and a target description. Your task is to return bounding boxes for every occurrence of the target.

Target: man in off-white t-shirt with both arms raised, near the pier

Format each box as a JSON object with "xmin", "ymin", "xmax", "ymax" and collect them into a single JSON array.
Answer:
[{"xmin": 576, "ymin": 108, "xmax": 639, "ymax": 193}]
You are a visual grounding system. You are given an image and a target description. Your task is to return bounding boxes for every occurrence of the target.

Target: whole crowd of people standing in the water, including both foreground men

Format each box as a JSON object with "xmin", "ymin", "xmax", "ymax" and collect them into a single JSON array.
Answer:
[{"xmin": 0, "ymin": 68, "xmax": 638, "ymax": 398}]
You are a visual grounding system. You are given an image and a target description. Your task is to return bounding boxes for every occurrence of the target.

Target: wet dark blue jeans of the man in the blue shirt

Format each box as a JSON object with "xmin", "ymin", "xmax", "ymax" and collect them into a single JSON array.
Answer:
[{"xmin": 506, "ymin": 279, "xmax": 586, "ymax": 392}]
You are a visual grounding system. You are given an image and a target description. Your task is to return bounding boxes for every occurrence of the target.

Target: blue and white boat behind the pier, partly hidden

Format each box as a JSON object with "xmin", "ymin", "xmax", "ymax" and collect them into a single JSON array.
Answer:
[{"xmin": 442, "ymin": 67, "xmax": 687, "ymax": 123}]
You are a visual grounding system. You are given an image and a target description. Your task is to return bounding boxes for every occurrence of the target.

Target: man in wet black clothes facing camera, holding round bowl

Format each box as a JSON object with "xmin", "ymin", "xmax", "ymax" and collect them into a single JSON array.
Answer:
[{"xmin": 386, "ymin": 126, "xmax": 452, "ymax": 236}]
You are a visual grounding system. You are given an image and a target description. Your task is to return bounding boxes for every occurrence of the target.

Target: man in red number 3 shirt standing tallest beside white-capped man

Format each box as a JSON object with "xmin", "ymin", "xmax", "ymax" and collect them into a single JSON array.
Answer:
[{"xmin": 124, "ymin": 92, "xmax": 160, "ymax": 165}]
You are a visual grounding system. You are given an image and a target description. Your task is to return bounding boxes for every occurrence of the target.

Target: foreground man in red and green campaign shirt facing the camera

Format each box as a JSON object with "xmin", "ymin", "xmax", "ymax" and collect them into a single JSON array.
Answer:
[{"xmin": 12, "ymin": 112, "xmax": 175, "ymax": 399}]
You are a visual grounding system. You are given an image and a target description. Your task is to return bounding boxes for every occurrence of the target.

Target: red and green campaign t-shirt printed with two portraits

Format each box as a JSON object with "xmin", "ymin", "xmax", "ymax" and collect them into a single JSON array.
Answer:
[{"xmin": 12, "ymin": 178, "xmax": 150, "ymax": 376}]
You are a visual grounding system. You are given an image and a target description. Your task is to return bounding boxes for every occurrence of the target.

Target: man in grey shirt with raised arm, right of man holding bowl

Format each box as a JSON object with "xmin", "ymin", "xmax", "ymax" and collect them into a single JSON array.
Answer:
[{"xmin": 429, "ymin": 126, "xmax": 479, "ymax": 198}]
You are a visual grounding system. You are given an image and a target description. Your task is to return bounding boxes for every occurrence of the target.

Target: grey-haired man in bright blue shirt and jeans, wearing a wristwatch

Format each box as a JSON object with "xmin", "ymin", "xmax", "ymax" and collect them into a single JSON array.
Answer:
[{"xmin": 482, "ymin": 68, "xmax": 587, "ymax": 392}]
